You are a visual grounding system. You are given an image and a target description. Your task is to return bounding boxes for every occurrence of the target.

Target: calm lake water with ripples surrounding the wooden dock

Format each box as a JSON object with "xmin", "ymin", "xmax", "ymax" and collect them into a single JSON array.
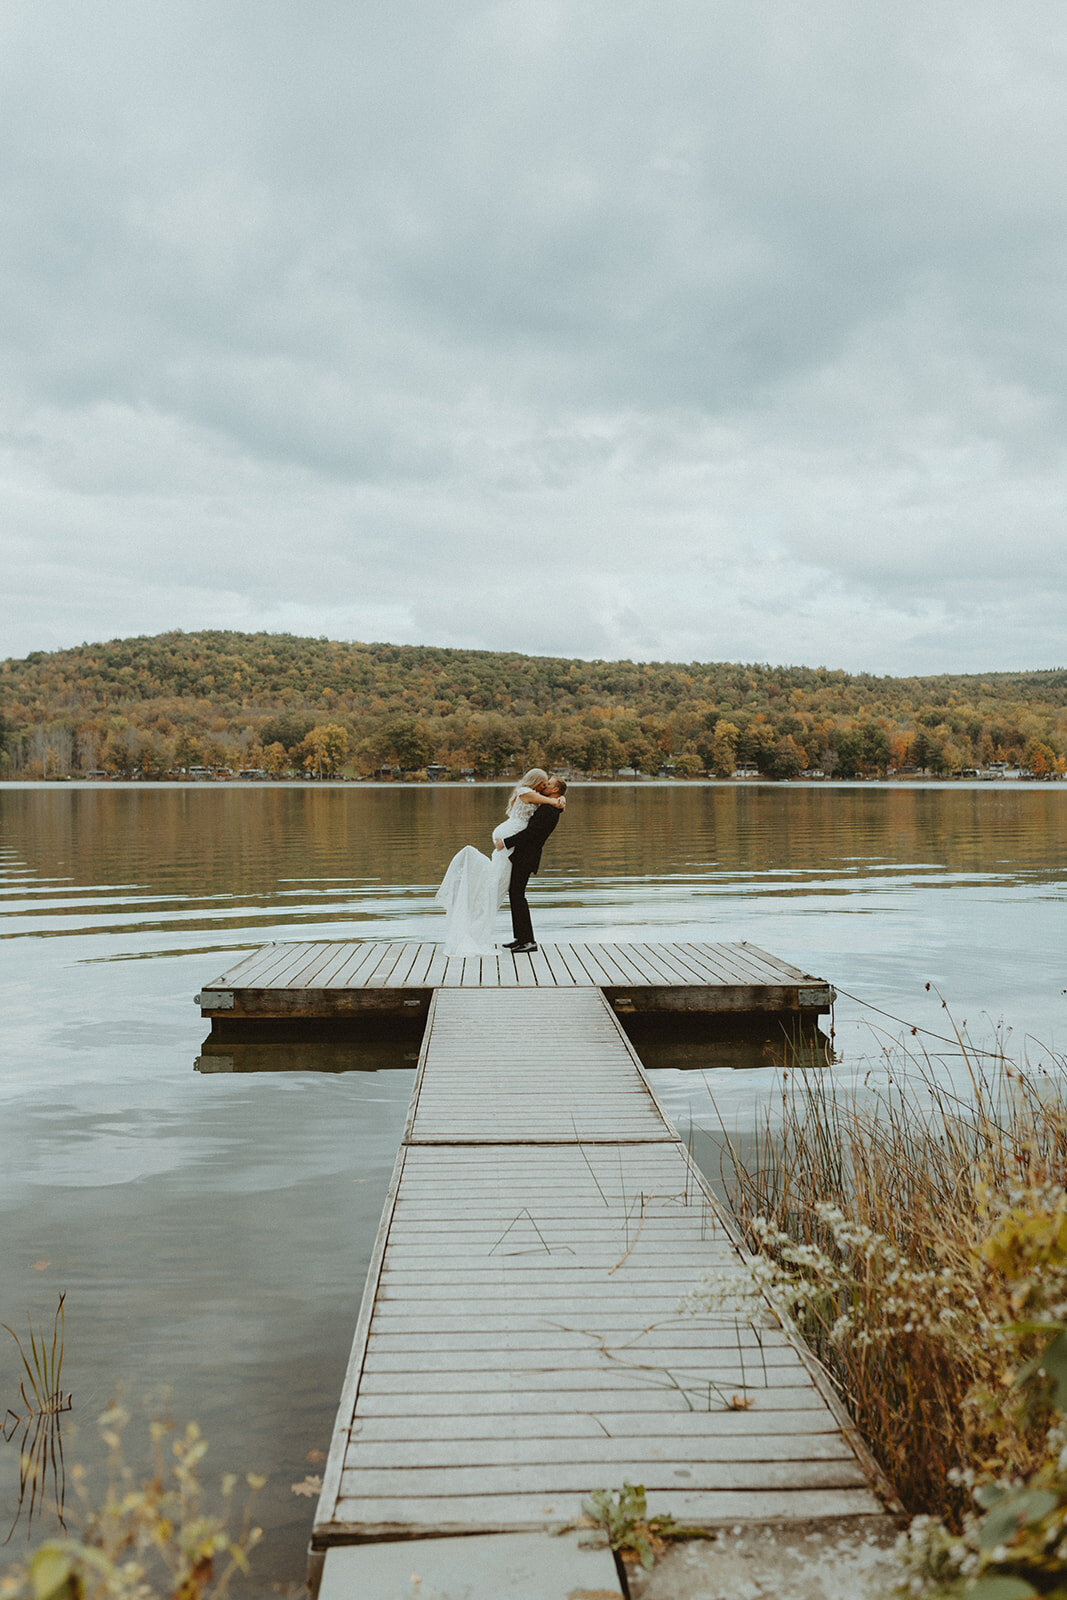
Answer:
[{"xmin": 0, "ymin": 784, "xmax": 1067, "ymax": 1594}]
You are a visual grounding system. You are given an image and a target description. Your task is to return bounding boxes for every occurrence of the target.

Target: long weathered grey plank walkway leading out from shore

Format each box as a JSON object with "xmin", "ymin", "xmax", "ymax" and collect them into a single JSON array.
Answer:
[{"xmin": 312, "ymin": 979, "xmax": 883, "ymax": 1550}]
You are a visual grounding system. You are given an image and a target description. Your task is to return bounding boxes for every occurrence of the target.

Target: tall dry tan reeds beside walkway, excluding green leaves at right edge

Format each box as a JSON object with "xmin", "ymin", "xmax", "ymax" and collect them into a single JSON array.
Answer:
[{"xmin": 721, "ymin": 1019, "xmax": 1067, "ymax": 1522}]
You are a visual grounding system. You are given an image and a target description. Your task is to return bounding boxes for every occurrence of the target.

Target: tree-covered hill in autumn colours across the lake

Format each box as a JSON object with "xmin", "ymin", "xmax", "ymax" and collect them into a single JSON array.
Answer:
[{"xmin": 0, "ymin": 632, "xmax": 1067, "ymax": 776}]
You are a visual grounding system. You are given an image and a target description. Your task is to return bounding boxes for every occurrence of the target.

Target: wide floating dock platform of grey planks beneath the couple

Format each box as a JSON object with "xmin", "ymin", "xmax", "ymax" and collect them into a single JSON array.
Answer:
[{"xmin": 197, "ymin": 939, "xmax": 833, "ymax": 1019}]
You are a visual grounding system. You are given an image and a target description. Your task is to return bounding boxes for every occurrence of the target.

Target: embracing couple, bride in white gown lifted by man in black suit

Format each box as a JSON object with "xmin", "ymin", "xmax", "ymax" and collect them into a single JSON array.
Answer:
[{"xmin": 435, "ymin": 766, "xmax": 566, "ymax": 955}]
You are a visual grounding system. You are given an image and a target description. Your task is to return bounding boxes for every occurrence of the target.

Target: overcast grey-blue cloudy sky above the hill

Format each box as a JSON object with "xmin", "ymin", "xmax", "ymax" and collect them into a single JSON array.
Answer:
[{"xmin": 0, "ymin": 0, "xmax": 1067, "ymax": 672}]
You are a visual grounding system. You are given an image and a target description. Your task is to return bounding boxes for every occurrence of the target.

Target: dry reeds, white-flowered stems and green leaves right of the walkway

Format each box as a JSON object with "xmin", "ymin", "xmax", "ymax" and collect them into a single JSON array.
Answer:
[{"xmin": 689, "ymin": 1002, "xmax": 1067, "ymax": 1600}]
